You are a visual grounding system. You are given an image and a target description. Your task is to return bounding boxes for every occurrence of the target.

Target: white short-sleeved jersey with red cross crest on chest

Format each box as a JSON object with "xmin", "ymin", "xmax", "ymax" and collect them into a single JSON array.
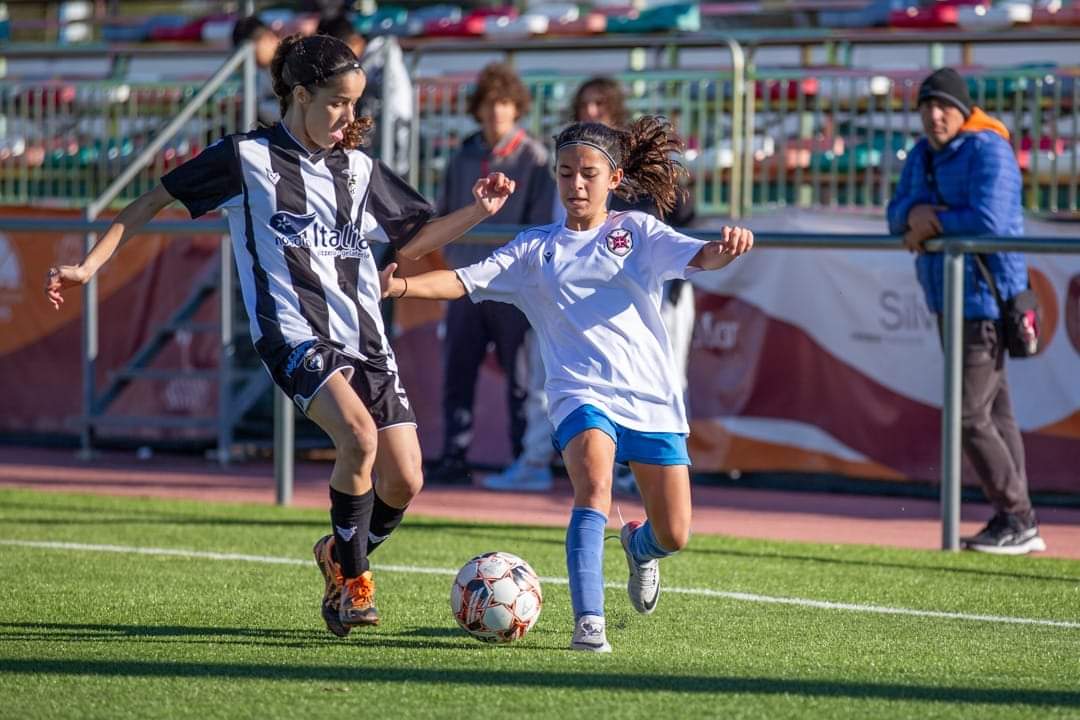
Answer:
[{"xmin": 457, "ymin": 212, "xmax": 705, "ymax": 433}]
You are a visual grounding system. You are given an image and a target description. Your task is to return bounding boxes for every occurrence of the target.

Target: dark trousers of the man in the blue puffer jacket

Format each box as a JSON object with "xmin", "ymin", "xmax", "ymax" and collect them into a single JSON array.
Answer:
[{"xmin": 960, "ymin": 320, "xmax": 1031, "ymax": 517}]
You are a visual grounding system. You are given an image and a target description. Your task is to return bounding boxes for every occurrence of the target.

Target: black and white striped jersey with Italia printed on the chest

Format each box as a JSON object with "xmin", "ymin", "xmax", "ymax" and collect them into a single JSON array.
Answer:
[{"xmin": 161, "ymin": 123, "xmax": 435, "ymax": 369}]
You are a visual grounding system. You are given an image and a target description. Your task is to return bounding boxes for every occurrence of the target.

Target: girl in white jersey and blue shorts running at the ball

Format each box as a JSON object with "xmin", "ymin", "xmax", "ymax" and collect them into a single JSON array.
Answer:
[{"xmin": 382, "ymin": 117, "xmax": 754, "ymax": 652}]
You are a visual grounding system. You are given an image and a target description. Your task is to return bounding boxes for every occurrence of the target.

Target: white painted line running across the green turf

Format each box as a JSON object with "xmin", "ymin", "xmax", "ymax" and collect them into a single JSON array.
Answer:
[{"xmin": 8, "ymin": 540, "xmax": 1080, "ymax": 629}]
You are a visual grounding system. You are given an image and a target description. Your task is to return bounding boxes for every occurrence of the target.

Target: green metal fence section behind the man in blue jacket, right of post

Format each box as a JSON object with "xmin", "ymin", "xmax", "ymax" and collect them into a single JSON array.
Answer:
[{"xmin": 745, "ymin": 67, "xmax": 1080, "ymax": 214}]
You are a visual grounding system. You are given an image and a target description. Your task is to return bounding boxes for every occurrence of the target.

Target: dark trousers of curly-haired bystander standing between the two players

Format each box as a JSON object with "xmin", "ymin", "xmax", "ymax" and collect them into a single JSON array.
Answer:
[{"xmin": 443, "ymin": 297, "xmax": 529, "ymax": 458}]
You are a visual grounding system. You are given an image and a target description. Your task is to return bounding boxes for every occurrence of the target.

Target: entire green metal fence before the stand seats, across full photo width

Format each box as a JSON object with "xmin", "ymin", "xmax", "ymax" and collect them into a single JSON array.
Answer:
[{"xmin": 0, "ymin": 36, "xmax": 1080, "ymax": 216}]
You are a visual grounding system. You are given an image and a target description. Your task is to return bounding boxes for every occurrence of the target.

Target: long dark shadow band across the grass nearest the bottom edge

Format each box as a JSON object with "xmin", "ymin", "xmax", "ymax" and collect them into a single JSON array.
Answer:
[{"xmin": 0, "ymin": 651, "xmax": 1080, "ymax": 708}]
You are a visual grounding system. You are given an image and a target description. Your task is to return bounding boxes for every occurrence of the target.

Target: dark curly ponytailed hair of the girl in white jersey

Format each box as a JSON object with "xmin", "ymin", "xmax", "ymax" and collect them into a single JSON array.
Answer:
[{"xmin": 555, "ymin": 116, "xmax": 686, "ymax": 215}]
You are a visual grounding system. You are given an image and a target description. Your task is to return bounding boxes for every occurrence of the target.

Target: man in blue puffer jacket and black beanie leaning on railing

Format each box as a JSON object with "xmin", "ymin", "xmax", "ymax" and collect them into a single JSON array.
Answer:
[{"xmin": 888, "ymin": 68, "xmax": 1047, "ymax": 555}]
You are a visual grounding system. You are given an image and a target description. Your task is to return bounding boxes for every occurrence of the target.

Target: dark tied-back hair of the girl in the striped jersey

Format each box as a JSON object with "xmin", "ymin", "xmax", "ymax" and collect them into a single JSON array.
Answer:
[{"xmin": 270, "ymin": 35, "xmax": 375, "ymax": 150}]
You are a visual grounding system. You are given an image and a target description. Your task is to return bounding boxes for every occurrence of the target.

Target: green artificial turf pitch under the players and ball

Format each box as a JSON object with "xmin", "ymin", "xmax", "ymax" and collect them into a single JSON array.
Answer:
[{"xmin": 0, "ymin": 490, "xmax": 1080, "ymax": 720}]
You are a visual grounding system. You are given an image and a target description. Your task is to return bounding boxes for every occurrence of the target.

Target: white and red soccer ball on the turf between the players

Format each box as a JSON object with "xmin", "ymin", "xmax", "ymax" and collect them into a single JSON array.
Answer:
[{"xmin": 450, "ymin": 553, "xmax": 543, "ymax": 643}]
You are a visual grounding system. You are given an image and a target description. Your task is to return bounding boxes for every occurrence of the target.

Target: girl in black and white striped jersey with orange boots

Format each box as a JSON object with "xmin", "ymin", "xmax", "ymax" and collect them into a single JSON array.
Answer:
[{"xmin": 45, "ymin": 36, "xmax": 514, "ymax": 637}]
